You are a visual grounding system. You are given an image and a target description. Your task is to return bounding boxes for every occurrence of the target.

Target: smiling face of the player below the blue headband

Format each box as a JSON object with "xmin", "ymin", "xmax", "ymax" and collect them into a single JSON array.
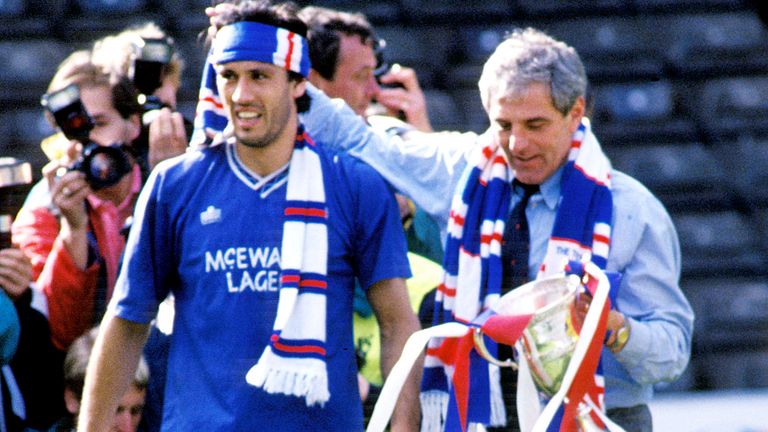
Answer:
[{"xmin": 216, "ymin": 61, "xmax": 305, "ymax": 148}]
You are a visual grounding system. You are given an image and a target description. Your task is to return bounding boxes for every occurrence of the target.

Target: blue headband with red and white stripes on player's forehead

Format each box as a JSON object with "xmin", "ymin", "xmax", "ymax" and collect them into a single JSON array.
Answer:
[{"xmin": 211, "ymin": 21, "xmax": 310, "ymax": 78}]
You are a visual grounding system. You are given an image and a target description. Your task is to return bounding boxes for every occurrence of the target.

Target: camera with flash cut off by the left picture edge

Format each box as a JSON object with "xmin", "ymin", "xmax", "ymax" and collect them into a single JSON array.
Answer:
[{"xmin": 0, "ymin": 157, "xmax": 32, "ymax": 249}]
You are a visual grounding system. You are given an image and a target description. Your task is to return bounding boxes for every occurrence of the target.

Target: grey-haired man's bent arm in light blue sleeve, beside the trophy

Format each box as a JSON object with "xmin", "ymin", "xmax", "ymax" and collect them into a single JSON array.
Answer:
[{"xmin": 608, "ymin": 186, "xmax": 693, "ymax": 384}]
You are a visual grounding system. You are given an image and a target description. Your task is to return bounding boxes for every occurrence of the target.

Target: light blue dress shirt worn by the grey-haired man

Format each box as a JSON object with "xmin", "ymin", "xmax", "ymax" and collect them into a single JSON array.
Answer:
[{"xmin": 302, "ymin": 86, "xmax": 693, "ymax": 408}]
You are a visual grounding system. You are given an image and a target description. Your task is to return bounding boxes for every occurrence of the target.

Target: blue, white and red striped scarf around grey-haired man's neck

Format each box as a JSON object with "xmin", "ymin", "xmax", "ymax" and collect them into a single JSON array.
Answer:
[{"xmin": 421, "ymin": 118, "xmax": 612, "ymax": 431}]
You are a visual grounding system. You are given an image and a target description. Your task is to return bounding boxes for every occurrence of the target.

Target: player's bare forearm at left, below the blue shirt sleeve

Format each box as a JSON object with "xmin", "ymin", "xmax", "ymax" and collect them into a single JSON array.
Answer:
[{"xmin": 78, "ymin": 313, "xmax": 149, "ymax": 431}]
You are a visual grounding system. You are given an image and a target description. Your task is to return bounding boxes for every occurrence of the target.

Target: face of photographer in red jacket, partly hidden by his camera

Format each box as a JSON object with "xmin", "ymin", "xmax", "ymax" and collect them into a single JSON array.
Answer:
[{"xmin": 80, "ymin": 85, "xmax": 141, "ymax": 146}]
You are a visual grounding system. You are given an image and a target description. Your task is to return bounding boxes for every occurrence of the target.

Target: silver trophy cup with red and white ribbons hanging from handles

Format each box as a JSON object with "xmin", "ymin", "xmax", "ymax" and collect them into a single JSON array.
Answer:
[{"xmin": 367, "ymin": 262, "xmax": 623, "ymax": 432}]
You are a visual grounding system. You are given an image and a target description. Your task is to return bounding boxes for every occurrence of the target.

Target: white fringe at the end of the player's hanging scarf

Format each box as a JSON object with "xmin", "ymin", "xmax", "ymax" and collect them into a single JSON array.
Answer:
[{"xmin": 245, "ymin": 350, "xmax": 331, "ymax": 407}]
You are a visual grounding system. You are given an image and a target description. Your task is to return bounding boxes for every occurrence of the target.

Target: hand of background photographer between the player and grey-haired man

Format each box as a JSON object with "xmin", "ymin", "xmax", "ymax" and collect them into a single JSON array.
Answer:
[{"xmin": 376, "ymin": 63, "xmax": 432, "ymax": 132}]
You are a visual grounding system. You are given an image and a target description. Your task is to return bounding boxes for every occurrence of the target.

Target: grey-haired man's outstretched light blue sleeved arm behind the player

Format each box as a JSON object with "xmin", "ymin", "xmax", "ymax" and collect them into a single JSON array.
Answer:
[{"xmin": 302, "ymin": 85, "xmax": 478, "ymax": 221}]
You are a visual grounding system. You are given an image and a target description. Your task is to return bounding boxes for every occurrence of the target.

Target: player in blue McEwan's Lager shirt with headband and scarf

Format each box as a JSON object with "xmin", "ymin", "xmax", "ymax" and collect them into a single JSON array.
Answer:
[{"xmin": 80, "ymin": 1, "xmax": 419, "ymax": 431}]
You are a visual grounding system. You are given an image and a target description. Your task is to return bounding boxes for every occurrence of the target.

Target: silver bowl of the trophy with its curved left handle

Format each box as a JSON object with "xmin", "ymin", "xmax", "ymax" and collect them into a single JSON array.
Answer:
[{"xmin": 475, "ymin": 275, "xmax": 581, "ymax": 397}]
